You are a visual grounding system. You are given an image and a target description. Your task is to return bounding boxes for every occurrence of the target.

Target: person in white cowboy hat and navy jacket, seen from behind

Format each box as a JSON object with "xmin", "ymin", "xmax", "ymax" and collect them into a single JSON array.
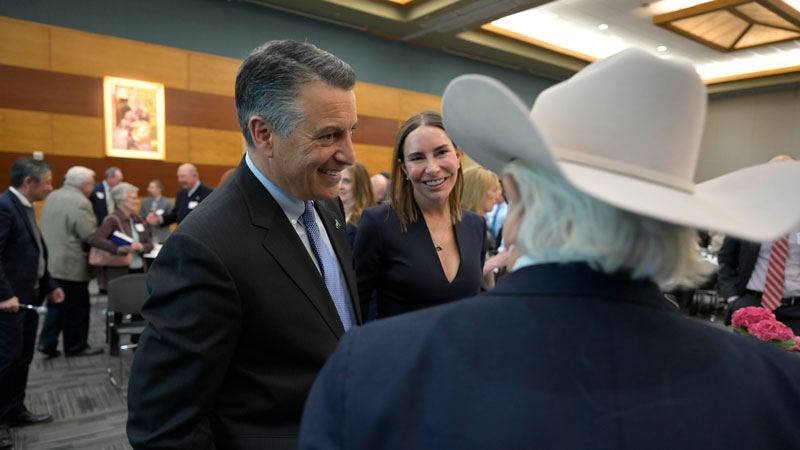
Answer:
[{"xmin": 300, "ymin": 49, "xmax": 800, "ymax": 449}]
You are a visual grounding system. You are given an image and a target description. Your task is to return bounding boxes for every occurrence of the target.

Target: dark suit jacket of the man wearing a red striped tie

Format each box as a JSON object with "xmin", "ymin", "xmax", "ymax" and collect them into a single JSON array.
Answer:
[{"xmin": 717, "ymin": 237, "xmax": 761, "ymax": 298}]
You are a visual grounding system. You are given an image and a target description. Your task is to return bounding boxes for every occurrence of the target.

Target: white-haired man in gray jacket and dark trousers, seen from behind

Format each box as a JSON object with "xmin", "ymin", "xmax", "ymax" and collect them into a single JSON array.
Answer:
[{"xmin": 39, "ymin": 166, "xmax": 103, "ymax": 356}]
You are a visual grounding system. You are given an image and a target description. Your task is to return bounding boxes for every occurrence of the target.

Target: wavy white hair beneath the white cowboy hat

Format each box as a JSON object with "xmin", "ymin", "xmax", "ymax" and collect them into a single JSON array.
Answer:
[{"xmin": 503, "ymin": 162, "xmax": 713, "ymax": 288}]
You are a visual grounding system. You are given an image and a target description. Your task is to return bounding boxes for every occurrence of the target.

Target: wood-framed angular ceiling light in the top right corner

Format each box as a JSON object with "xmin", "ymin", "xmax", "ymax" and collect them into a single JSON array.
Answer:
[{"xmin": 653, "ymin": 0, "xmax": 800, "ymax": 52}]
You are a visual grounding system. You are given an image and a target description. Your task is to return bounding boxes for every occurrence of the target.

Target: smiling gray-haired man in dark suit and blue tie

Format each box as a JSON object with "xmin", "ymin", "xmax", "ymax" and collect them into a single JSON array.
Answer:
[{"xmin": 128, "ymin": 41, "xmax": 361, "ymax": 449}]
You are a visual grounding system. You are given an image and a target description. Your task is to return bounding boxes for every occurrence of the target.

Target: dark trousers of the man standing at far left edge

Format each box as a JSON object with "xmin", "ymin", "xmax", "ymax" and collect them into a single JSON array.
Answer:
[{"xmin": 0, "ymin": 309, "xmax": 39, "ymax": 423}]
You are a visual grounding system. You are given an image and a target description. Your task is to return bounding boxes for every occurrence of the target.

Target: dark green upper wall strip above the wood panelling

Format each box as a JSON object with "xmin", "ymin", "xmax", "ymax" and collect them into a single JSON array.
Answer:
[{"xmin": 0, "ymin": 0, "xmax": 554, "ymax": 105}]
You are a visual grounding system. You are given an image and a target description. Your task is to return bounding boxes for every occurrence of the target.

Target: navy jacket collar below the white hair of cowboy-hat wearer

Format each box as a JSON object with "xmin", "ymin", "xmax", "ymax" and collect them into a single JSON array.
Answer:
[{"xmin": 490, "ymin": 262, "xmax": 678, "ymax": 313}]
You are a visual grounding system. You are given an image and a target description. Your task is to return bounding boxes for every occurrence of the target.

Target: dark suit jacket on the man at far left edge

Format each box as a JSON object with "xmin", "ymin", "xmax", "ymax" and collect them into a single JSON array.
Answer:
[{"xmin": 0, "ymin": 191, "xmax": 58, "ymax": 306}]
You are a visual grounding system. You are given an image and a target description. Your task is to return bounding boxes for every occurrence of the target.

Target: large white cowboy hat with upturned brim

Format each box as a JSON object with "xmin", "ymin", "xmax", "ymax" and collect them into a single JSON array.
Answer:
[{"xmin": 442, "ymin": 49, "xmax": 800, "ymax": 242}]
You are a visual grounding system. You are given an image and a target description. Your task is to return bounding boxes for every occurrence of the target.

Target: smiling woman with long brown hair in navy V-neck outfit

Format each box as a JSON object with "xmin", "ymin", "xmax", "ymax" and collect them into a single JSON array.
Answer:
[{"xmin": 353, "ymin": 111, "xmax": 486, "ymax": 318}]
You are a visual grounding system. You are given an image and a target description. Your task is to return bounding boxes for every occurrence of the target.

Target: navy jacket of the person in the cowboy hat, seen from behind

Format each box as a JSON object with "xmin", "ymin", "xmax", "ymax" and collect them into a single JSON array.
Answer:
[{"xmin": 300, "ymin": 264, "xmax": 800, "ymax": 450}]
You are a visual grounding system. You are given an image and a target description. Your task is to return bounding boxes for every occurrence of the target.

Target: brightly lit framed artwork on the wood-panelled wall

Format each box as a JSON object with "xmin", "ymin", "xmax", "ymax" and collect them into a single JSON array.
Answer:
[{"xmin": 103, "ymin": 77, "xmax": 166, "ymax": 159}]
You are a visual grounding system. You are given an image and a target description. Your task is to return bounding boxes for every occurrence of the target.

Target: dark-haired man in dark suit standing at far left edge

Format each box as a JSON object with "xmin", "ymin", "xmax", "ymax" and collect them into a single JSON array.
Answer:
[{"xmin": 0, "ymin": 158, "xmax": 64, "ymax": 448}]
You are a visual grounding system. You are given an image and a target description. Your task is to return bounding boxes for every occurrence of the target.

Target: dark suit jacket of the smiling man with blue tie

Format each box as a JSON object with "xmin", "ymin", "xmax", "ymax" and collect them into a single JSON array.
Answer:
[{"xmin": 128, "ymin": 157, "xmax": 362, "ymax": 449}]
